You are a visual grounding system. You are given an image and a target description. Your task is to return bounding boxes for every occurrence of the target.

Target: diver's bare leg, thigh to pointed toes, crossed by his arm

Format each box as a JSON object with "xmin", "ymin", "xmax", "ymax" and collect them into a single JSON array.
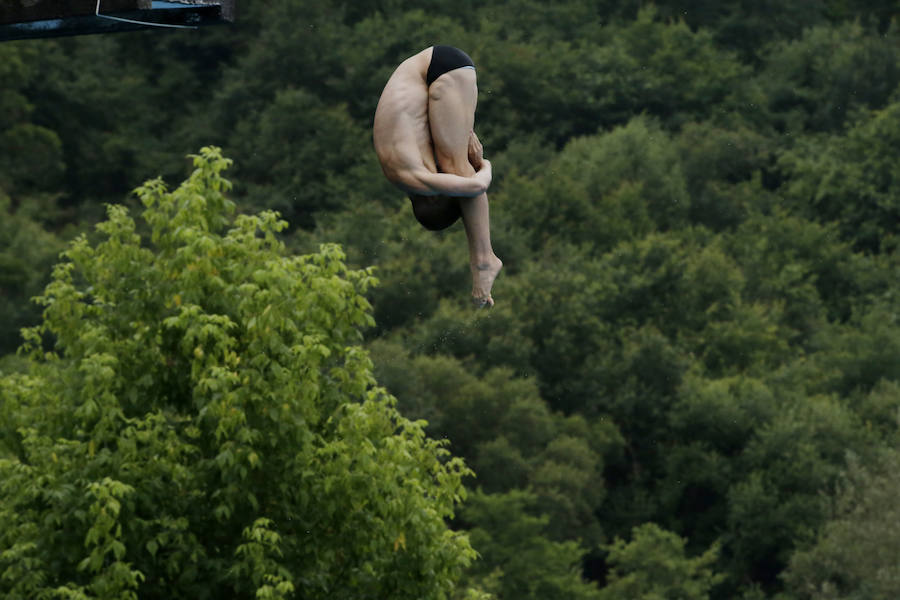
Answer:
[{"xmin": 428, "ymin": 68, "xmax": 503, "ymax": 305}]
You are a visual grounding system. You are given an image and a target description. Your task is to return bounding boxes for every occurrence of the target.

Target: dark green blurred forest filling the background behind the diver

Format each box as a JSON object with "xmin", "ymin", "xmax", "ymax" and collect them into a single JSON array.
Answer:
[{"xmin": 0, "ymin": 0, "xmax": 900, "ymax": 600}]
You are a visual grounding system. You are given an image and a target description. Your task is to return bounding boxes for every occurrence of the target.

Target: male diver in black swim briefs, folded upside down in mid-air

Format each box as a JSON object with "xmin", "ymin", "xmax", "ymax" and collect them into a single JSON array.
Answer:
[{"xmin": 373, "ymin": 46, "xmax": 503, "ymax": 307}]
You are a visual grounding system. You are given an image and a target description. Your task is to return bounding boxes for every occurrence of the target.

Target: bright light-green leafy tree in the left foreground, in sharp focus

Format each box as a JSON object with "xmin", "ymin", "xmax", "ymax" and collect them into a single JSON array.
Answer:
[{"xmin": 0, "ymin": 148, "xmax": 475, "ymax": 599}]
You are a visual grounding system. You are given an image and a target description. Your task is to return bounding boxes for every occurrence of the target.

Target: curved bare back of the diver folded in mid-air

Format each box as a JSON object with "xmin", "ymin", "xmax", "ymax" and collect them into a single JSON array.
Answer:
[{"xmin": 373, "ymin": 48, "xmax": 437, "ymax": 193}]
